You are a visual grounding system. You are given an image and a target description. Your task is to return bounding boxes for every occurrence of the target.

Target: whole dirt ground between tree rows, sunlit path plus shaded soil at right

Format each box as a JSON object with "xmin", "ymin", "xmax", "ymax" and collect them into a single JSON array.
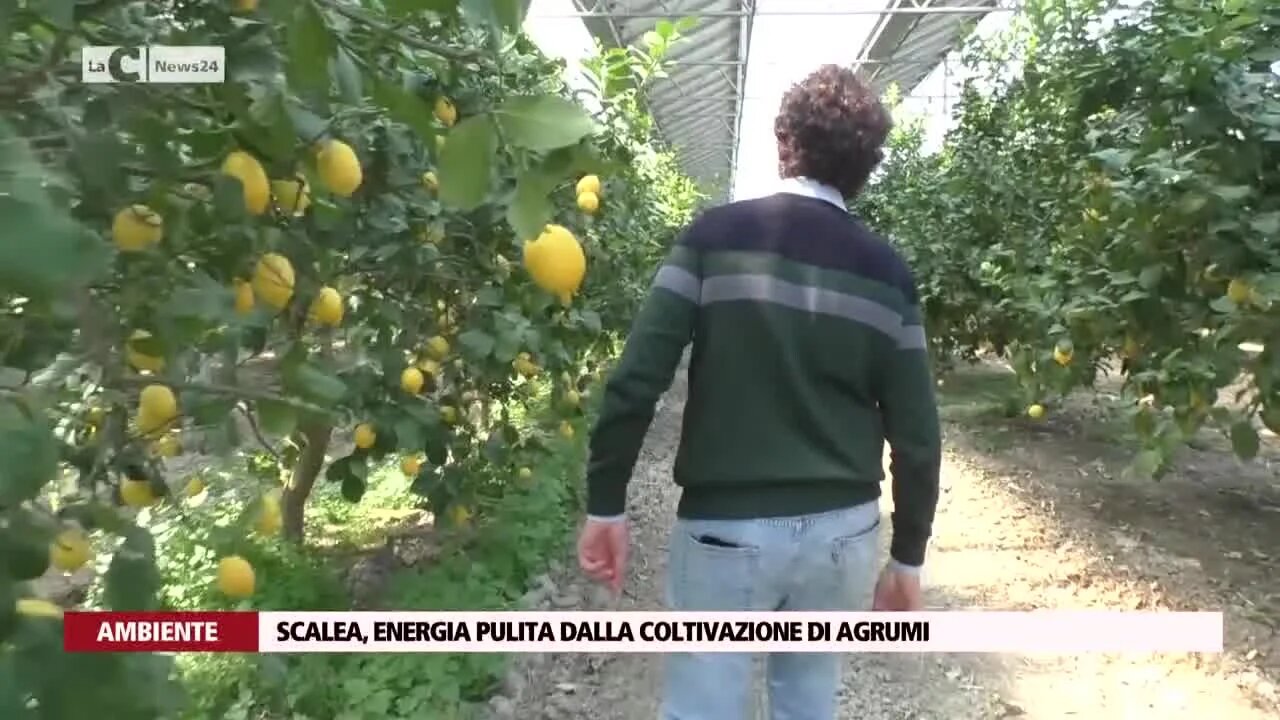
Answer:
[{"xmin": 493, "ymin": 368, "xmax": 1280, "ymax": 720}]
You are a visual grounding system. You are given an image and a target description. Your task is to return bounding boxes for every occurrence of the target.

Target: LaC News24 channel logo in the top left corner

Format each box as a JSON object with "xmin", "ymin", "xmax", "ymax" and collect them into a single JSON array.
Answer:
[{"xmin": 81, "ymin": 45, "xmax": 227, "ymax": 85}]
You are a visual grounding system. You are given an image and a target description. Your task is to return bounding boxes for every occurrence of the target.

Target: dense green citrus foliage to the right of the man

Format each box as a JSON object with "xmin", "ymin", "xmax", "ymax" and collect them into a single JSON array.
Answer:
[{"xmin": 859, "ymin": 0, "xmax": 1280, "ymax": 474}]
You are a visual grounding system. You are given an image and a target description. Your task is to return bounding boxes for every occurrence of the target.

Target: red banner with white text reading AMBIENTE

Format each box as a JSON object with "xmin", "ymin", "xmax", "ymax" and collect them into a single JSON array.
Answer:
[{"xmin": 63, "ymin": 612, "xmax": 257, "ymax": 652}]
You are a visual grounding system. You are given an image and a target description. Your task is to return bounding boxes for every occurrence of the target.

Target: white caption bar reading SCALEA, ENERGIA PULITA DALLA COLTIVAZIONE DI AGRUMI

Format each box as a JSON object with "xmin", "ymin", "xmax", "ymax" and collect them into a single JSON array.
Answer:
[{"xmin": 259, "ymin": 611, "xmax": 1222, "ymax": 653}]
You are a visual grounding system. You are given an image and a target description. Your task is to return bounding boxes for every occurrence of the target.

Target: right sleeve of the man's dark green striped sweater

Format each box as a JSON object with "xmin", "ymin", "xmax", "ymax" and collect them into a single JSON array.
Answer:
[{"xmin": 879, "ymin": 272, "xmax": 942, "ymax": 568}]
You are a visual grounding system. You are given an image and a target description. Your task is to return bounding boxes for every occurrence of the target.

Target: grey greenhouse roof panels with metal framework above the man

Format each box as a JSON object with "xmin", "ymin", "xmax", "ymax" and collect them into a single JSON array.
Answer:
[{"xmin": 555, "ymin": 0, "xmax": 1012, "ymax": 201}]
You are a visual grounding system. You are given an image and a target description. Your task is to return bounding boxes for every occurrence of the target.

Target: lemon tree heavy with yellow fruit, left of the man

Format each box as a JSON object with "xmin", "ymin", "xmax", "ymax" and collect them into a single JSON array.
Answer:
[{"xmin": 0, "ymin": 0, "xmax": 699, "ymax": 719}]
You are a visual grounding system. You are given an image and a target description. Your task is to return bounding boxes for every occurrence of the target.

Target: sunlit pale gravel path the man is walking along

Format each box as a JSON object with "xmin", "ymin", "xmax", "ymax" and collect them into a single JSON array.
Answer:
[{"xmin": 493, "ymin": 366, "xmax": 1280, "ymax": 720}]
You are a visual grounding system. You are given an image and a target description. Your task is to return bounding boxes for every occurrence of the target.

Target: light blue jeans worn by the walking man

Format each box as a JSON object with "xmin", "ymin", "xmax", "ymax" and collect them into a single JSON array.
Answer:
[{"xmin": 660, "ymin": 502, "xmax": 879, "ymax": 720}]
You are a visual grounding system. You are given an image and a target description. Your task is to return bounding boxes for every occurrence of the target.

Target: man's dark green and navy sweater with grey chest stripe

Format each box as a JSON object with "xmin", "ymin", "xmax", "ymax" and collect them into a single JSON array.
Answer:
[{"xmin": 588, "ymin": 179, "xmax": 941, "ymax": 566}]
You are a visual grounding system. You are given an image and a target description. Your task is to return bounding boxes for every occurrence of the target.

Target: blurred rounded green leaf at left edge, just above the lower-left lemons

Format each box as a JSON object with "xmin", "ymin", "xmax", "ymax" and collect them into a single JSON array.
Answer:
[{"xmin": 0, "ymin": 400, "xmax": 59, "ymax": 506}]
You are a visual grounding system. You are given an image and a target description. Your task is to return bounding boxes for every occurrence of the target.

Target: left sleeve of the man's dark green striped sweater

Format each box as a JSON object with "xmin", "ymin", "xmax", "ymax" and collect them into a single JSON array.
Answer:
[{"xmin": 586, "ymin": 231, "xmax": 701, "ymax": 518}]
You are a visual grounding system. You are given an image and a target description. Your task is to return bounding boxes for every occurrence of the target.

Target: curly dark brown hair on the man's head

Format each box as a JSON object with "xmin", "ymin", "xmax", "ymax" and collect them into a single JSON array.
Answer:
[{"xmin": 773, "ymin": 65, "xmax": 893, "ymax": 199}]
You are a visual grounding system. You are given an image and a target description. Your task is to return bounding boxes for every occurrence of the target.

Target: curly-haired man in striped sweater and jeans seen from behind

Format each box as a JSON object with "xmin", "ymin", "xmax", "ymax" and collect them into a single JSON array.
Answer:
[{"xmin": 579, "ymin": 65, "xmax": 941, "ymax": 720}]
